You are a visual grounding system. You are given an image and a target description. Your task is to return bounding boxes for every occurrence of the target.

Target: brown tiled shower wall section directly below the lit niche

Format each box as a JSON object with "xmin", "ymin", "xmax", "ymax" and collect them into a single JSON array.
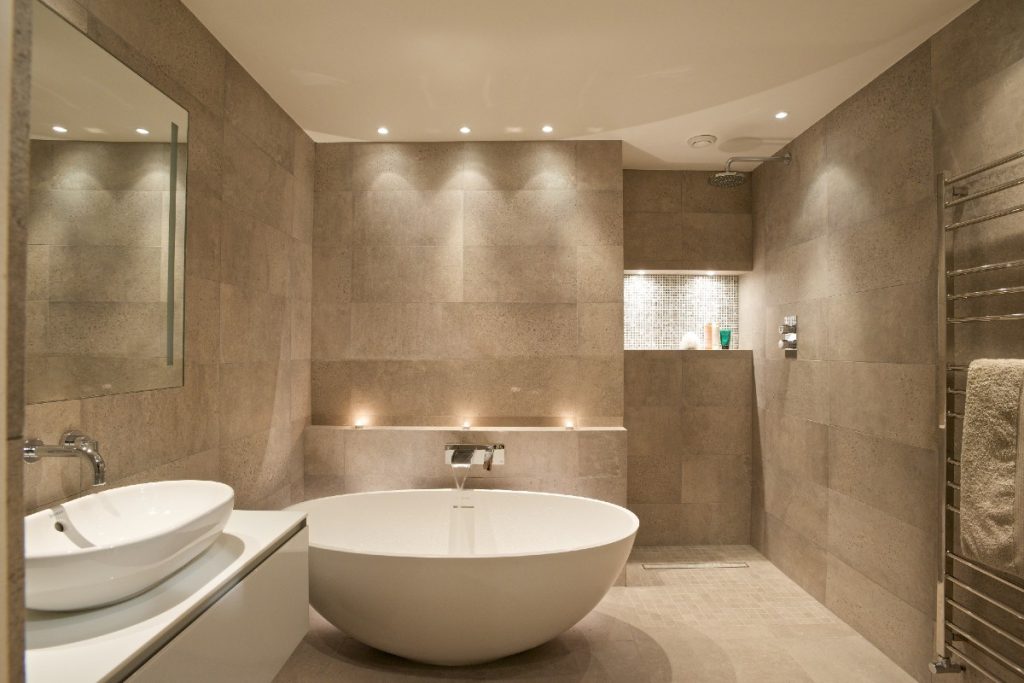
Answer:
[{"xmin": 625, "ymin": 351, "xmax": 753, "ymax": 545}]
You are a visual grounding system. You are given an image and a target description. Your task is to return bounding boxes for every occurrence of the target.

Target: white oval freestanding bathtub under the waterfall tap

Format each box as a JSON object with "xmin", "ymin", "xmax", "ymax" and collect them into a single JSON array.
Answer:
[{"xmin": 292, "ymin": 489, "xmax": 639, "ymax": 666}]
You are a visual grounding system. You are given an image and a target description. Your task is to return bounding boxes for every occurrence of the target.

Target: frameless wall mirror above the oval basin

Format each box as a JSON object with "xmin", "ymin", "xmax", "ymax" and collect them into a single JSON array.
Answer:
[{"xmin": 26, "ymin": 0, "xmax": 188, "ymax": 403}]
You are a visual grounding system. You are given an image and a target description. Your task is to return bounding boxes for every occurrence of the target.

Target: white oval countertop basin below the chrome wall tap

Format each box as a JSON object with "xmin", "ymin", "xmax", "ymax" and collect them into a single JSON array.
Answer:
[{"xmin": 25, "ymin": 481, "xmax": 234, "ymax": 610}]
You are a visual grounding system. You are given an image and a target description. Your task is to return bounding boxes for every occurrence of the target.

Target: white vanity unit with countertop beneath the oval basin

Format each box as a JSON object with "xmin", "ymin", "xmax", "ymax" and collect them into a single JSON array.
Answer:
[{"xmin": 26, "ymin": 510, "xmax": 309, "ymax": 683}]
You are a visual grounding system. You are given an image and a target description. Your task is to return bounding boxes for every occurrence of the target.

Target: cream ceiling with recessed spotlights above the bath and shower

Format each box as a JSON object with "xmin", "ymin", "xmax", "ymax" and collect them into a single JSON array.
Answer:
[{"xmin": 184, "ymin": 0, "xmax": 975, "ymax": 169}]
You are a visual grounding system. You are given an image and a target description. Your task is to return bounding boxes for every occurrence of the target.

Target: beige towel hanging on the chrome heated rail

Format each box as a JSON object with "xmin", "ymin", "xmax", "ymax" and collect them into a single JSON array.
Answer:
[{"xmin": 959, "ymin": 359, "xmax": 1024, "ymax": 577}]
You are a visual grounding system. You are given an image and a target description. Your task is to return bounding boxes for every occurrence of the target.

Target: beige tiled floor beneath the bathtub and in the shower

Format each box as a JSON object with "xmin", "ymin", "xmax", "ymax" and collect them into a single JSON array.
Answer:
[{"xmin": 278, "ymin": 546, "xmax": 912, "ymax": 683}]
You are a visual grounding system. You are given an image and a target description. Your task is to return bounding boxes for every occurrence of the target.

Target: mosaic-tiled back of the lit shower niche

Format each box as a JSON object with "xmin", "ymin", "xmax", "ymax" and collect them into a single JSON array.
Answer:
[{"xmin": 624, "ymin": 273, "xmax": 739, "ymax": 351}]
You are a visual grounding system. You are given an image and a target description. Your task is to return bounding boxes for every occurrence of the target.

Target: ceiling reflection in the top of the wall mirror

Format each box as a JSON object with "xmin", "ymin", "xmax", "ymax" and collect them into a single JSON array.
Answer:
[{"xmin": 30, "ymin": 2, "xmax": 188, "ymax": 142}]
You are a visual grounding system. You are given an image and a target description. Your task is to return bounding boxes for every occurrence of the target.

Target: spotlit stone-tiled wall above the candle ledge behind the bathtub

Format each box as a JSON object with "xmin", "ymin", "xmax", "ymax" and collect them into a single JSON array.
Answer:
[{"xmin": 310, "ymin": 141, "xmax": 623, "ymax": 423}]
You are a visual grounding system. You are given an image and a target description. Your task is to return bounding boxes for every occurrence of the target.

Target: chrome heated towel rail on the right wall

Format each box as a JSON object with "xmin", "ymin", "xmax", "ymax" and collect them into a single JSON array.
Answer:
[{"xmin": 932, "ymin": 150, "xmax": 1024, "ymax": 682}]
